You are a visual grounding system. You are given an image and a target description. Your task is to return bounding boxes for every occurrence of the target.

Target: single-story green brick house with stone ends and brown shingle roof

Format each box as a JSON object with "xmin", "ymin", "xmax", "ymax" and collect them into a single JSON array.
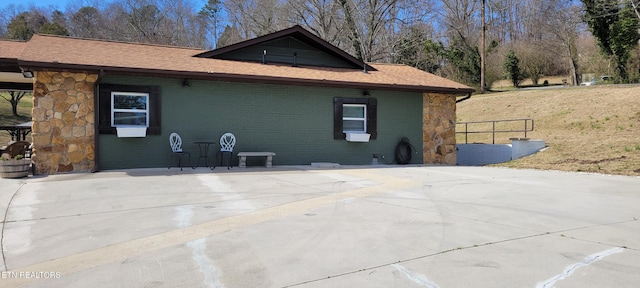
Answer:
[{"xmin": 0, "ymin": 26, "xmax": 473, "ymax": 174}]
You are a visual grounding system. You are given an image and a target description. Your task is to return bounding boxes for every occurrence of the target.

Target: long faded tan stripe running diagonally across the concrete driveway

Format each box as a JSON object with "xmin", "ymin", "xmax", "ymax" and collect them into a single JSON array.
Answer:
[{"xmin": 3, "ymin": 170, "xmax": 421, "ymax": 287}]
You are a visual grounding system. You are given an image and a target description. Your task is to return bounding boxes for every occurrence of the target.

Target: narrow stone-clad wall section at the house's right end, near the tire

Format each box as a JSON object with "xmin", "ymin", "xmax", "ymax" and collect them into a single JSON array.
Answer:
[{"xmin": 422, "ymin": 93, "xmax": 456, "ymax": 165}]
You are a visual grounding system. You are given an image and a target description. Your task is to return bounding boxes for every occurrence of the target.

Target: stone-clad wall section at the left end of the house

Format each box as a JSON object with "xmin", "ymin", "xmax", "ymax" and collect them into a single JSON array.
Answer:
[{"xmin": 32, "ymin": 71, "xmax": 98, "ymax": 174}]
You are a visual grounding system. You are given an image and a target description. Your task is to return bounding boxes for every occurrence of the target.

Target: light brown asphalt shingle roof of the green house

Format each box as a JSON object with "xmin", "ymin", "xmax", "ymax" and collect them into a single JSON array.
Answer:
[{"xmin": 0, "ymin": 35, "xmax": 473, "ymax": 94}]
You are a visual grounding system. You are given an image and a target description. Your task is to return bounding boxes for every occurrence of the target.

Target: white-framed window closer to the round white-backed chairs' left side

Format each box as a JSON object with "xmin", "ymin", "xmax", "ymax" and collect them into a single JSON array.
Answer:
[{"xmin": 111, "ymin": 91, "xmax": 149, "ymax": 127}]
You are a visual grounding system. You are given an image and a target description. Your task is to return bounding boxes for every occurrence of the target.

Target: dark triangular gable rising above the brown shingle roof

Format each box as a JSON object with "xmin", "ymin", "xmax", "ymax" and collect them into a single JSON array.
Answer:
[{"xmin": 196, "ymin": 25, "xmax": 375, "ymax": 70}]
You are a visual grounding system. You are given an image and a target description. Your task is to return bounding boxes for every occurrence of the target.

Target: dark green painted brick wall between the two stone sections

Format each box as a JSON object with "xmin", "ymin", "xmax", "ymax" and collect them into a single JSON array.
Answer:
[{"xmin": 98, "ymin": 76, "xmax": 422, "ymax": 170}]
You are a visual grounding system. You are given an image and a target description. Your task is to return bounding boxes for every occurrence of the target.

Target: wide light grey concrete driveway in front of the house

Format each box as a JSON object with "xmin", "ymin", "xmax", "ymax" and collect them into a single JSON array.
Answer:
[{"xmin": 0, "ymin": 166, "xmax": 640, "ymax": 288}]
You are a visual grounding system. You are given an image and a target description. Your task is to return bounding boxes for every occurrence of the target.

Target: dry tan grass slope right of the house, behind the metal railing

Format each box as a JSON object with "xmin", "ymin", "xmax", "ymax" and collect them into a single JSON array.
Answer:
[{"xmin": 457, "ymin": 86, "xmax": 640, "ymax": 176}]
